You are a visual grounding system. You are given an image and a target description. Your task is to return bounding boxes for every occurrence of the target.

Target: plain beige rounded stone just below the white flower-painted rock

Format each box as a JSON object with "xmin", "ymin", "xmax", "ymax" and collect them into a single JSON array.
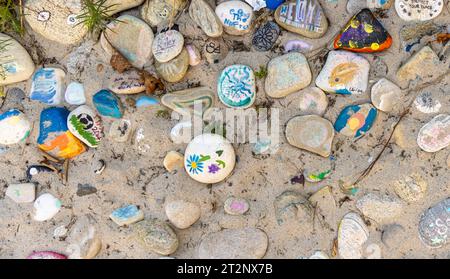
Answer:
[{"xmin": 164, "ymin": 200, "xmax": 201, "ymax": 230}]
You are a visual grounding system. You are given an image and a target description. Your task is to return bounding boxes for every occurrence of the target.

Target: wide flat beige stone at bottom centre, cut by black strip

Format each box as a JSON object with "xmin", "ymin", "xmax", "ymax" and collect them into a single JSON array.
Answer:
[{"xmin": 198, "ymin": 228, "xmax": 269, "ymax": 259}]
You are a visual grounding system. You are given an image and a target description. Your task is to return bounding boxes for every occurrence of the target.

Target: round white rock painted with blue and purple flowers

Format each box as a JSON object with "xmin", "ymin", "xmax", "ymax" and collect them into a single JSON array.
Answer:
[{"xmin": 184, "ymin": 134, "xmax": 236, "ymax": 184}]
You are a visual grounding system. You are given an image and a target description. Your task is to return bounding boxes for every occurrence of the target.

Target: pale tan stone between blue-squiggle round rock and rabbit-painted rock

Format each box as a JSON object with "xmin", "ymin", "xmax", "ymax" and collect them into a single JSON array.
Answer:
[{"xmin": 265, "ymin": 52, "xmax": 312, "ymax": 98}]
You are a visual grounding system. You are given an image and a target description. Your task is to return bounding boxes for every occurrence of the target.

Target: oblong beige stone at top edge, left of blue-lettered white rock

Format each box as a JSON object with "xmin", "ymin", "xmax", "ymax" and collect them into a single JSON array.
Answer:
[{"xmin": 189, "ymin": 0, "xmax": 223, "ymax": 37}]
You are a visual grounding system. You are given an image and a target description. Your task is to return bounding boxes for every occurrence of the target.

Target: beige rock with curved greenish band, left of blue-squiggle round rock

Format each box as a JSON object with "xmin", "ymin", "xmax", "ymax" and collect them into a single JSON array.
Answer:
[{"xmin": 161, "ymin": 87, "xmax": 214, "ymax": 116}]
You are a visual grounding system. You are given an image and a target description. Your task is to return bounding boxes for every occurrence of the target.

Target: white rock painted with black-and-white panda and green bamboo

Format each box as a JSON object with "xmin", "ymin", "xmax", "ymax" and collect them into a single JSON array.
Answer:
[{"xmin": 67, "ymin": 105, "xmax": 105, "ymax": 148}]
